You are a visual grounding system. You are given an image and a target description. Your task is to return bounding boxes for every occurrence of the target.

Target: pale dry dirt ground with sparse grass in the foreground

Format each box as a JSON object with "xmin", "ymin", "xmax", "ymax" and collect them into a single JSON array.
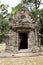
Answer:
[{"xmin": 0, "ymin": 56, "xmax": 43, "ymax": 65}]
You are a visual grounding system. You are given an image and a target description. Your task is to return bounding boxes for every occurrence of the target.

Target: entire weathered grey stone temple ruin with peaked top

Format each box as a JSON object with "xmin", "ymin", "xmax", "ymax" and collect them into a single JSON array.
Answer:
[{"xmin": 6, "ymin": 7, "xmax": 40, "ymax": 52}]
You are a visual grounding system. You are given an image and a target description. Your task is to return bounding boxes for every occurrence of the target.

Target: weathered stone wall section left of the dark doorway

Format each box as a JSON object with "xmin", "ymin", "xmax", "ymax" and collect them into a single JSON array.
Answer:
[{"xmin": 6, "ymin": 30, "xmax": 17, "ymax": 52}]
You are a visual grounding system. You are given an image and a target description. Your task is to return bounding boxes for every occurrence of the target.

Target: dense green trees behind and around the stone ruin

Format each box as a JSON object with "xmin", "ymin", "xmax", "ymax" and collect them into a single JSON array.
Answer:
[{"xmin": 0, "ymin": 0, "xmax": 43, "ymax": 43}]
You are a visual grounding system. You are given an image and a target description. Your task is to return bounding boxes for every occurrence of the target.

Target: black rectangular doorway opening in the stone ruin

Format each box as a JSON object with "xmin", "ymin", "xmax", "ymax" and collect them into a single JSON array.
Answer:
[{"xmin": 19, "ymin": 33, "xmax": 28, "ymax": 49}]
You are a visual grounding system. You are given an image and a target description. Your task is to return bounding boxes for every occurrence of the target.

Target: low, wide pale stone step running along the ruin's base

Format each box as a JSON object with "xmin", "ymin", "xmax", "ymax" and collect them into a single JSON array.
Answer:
[{"xmin": 0, "ymin": 51, "xmax": 43, "ymax": 58}]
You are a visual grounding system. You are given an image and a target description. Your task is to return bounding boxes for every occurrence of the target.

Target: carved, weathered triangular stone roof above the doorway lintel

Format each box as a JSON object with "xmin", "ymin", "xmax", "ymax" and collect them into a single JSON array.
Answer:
[{"xmin": 10, "ymin": 6, "xmax": 36, "ymax": 28}]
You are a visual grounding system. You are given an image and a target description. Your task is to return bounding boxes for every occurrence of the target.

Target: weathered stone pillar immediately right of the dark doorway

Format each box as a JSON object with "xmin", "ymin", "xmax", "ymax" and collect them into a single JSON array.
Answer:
[{"xmin": 28, "ymin": 31, "xmax": 35, "ymax": 48}]
